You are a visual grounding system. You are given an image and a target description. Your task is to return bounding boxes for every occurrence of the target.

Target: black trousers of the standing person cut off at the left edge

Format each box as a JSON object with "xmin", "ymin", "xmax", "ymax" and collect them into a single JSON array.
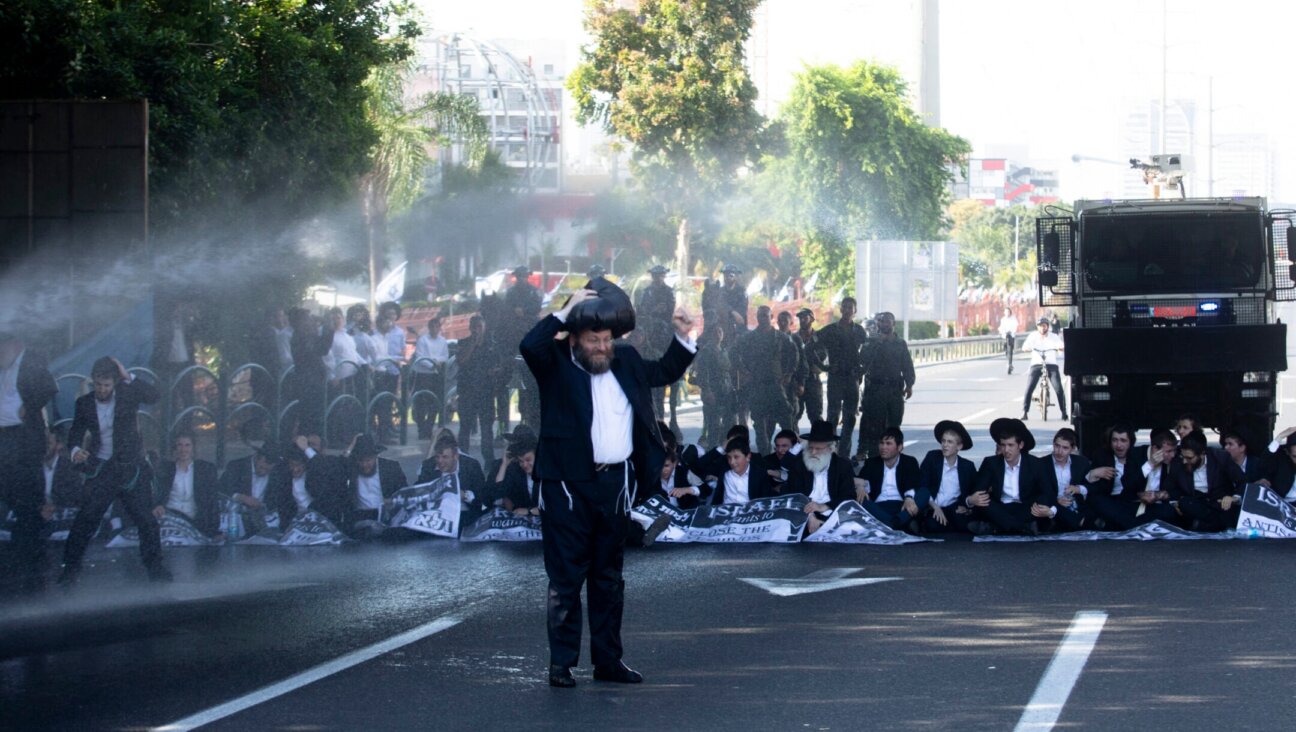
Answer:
[{"xmin": 0, "ymin": 425, "xmax": 45, "ymax": 586}]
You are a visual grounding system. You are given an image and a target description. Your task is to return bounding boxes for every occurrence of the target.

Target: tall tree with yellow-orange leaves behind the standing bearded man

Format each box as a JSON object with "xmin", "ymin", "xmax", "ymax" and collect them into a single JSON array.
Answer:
[{"xmin": 568, "ymin": 0, "xmax": 762, "ymax": 290}]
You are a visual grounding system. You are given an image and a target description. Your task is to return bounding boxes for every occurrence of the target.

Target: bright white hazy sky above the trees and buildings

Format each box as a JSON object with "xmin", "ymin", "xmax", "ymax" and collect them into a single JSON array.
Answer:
[{"xmin": 421, "ymin": 0, "xmax": 1296, "ymax": 202}]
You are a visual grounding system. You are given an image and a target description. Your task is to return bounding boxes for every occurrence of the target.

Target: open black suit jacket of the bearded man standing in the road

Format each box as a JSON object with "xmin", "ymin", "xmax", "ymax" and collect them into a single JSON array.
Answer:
[{"xmin": 518, "ymin": 315, "xmax": 693, "ymax": 503}]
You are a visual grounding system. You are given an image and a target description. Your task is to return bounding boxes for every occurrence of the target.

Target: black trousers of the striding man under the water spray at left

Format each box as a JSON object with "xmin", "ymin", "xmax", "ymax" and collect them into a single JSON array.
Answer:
[{"xmin": 64, "ymin": 460, "xmax": 162, "ymax": 570}]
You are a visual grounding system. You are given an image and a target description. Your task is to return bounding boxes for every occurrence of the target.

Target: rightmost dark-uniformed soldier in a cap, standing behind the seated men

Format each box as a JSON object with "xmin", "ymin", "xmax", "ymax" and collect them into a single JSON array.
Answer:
[{"xmin": 857, "ymin": 312, "xmax": 914, "ymax": 456}]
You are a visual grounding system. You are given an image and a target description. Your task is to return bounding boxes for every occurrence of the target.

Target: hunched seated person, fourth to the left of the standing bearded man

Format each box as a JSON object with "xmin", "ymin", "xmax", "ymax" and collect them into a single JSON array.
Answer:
[{"xmin": 277, "ymin": 435, "xmax": 347, "ymax": 531}]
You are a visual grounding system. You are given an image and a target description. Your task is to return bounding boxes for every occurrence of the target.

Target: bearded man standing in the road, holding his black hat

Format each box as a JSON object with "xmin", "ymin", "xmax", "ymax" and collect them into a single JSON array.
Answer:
[{"xmin": 520, "ymin": 279, "xmax": 696, "ymax": 688}]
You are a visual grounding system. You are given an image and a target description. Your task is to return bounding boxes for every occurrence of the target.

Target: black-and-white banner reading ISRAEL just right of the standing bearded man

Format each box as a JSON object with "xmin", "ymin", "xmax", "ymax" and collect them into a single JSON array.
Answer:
[{"xmin": 631, "ymin": 494, "xmax": 810, "ymax": 544}]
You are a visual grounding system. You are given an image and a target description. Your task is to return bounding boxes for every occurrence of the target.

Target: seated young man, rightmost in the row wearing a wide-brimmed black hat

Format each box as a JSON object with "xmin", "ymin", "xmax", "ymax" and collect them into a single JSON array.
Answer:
[{"xmin": 964, "ymin": 420, "xmax": 1056, "ymax": 535}]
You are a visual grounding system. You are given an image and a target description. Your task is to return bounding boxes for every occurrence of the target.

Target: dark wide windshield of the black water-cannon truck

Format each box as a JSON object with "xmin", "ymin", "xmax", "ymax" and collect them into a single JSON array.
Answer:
[{"xmin": 1080, "ymin": 212, "xmax": 1265, "ymax": 293}]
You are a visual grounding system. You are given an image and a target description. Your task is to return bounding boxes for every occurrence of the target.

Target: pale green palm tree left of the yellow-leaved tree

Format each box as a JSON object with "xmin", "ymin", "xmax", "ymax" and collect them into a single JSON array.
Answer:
[{"xmin": 360, "ymin": 58, "xmax": 489, "ymax": 310}]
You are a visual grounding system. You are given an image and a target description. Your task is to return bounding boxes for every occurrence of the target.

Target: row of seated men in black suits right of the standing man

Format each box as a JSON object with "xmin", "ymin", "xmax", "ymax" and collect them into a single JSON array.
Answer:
[{"xmin": 639, "ymin": 417, "xmax": 1296, "ymax": 542}]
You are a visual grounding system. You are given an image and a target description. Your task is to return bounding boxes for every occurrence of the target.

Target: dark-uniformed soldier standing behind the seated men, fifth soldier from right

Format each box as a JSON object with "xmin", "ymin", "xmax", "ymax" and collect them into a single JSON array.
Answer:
[{"xmin": 735, "ymin": 304, "xmax": 794, "ymax": 455}]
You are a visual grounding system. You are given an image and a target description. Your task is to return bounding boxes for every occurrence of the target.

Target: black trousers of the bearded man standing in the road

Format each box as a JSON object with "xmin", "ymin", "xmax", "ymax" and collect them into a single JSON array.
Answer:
[{"xmin": 540, "ymin": 468, "xmax": 634, "ymax": 667}]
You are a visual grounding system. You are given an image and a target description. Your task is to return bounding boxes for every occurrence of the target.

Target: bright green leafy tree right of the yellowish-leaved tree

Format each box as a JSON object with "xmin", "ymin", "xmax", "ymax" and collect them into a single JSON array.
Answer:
[{"xmin": 781, "ymin": 61, "xmax": 971, "ymax": 288}]
